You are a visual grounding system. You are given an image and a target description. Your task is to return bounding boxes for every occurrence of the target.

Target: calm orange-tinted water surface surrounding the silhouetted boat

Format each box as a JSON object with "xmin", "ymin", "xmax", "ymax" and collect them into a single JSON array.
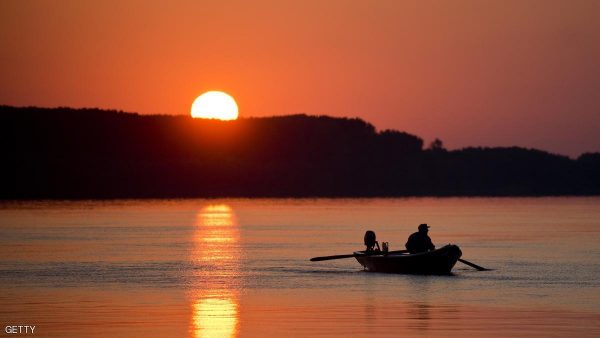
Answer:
[{"xmin": 0, "ymin": 198, "xmax": 600, "ymax": 337}]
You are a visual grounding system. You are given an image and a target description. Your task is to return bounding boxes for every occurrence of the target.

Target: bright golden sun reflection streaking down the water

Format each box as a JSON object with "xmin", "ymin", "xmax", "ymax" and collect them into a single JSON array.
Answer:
[{"xmin": 190, "ymin": 204, "xmax": 240, "ymax": 338}]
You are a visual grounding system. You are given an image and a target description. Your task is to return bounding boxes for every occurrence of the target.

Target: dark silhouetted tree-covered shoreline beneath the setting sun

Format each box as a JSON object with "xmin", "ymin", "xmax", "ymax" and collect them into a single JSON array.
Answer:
[{"xmin": 0, "ymin": 106, "xmax": 600, "ymax": 199}]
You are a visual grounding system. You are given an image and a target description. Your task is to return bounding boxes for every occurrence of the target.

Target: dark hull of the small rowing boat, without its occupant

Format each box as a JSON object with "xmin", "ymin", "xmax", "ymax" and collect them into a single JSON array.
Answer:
[{"xmin": 354, "ymin": 245, "xmax": 462, "ymax": 275}]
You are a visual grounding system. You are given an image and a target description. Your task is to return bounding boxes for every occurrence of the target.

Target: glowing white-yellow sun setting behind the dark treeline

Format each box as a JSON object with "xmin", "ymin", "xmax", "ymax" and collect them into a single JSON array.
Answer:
[{"xmin": 192, "ymin": 91, "xmax": 238, "ymax": 120}]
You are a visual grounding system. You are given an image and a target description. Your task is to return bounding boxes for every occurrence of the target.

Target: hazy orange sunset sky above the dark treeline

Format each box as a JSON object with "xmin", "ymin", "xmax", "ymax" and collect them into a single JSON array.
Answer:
[{"xmin": 0, "ymin": 0, "xmax": 600, "ymax": 157}]
